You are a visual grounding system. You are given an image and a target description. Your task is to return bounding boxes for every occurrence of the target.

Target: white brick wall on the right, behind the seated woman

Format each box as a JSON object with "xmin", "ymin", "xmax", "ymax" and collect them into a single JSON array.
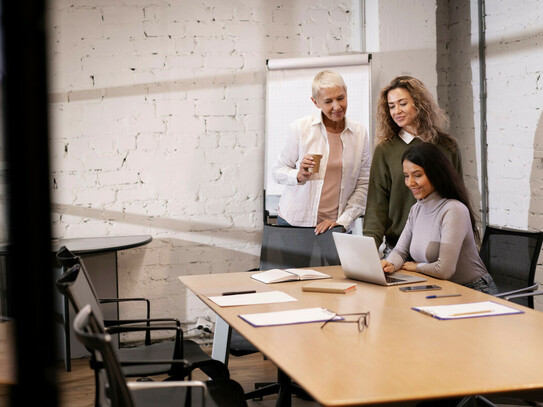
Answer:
[{"xmin": 438, "ymin": 0, "xmax": 543, "ymax": 309}]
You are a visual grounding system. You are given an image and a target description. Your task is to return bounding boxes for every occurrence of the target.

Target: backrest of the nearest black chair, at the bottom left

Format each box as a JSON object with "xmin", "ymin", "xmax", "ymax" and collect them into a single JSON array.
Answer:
[{"xmin": 73, "ymin": 306, "xmax": 134, "ymax": 407}]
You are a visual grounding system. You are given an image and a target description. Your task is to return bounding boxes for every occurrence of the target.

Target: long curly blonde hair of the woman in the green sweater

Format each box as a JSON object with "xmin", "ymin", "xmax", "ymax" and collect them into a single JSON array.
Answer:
[{"xmin": 376, "ymin": 76, "xmax": 456, "ymax": 151}]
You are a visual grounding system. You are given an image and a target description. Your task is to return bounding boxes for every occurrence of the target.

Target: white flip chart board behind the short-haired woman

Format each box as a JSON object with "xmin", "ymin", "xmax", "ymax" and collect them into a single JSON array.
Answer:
[{"xmin": 264, "ymin": 54, "xmax": 371, "ymax": 215}]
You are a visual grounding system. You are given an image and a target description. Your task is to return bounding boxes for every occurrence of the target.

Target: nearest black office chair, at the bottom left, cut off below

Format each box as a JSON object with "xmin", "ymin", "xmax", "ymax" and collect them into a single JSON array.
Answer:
[{"xmin": 73, "ymin": 304, "xmax": 247, "ymax": 407}]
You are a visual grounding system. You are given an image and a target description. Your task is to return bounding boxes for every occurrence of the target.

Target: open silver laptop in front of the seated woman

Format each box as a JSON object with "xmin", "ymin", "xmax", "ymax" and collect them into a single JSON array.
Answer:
[{"xmin": 333, "ymin": 232, "xmax": 426, "ymax": 286}]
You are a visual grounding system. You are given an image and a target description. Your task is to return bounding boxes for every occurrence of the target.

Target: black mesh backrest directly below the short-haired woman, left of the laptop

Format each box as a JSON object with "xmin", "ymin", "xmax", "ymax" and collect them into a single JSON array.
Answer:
[{"xmin": 260, "ymin": 224, "xmax": 345, "ymax": 270}]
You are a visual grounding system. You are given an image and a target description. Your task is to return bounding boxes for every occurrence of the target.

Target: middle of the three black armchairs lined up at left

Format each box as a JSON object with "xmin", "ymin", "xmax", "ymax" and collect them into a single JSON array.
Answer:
[{"xmin": 57, "ymin": 259, "xmax": 230, "ymax": 406}]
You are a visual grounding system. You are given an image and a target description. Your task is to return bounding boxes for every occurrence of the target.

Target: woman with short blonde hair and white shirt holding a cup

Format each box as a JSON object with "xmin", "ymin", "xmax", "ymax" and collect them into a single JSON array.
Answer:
[{"xmin": 272, "ymin": 70, "xmax": 371, "ymax": 235}]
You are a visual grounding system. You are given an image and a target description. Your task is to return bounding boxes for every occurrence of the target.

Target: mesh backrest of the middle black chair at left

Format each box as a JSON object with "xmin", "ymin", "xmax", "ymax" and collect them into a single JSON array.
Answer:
[{"xmin": 56, "ymin": 262, "xmax": 105, "ymax": 329}]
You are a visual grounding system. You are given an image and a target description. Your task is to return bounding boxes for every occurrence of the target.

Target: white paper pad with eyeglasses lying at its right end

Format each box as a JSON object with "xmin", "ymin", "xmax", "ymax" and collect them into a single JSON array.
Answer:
[{"xmin": 238, "ymin": 307, "xmax": 342, "ymax": 327}]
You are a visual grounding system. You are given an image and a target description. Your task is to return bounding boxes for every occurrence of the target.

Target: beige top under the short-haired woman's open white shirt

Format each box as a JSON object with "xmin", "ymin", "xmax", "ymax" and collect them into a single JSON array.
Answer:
[{"xmin": 317, "ymin": 131, "xmax": 343, "ymax": 224}]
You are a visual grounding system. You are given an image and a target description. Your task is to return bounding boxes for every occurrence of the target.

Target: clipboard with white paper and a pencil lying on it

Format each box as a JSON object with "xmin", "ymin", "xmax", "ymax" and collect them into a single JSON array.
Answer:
[{"xmin": 413, "ymin": 301, "xmax": 524, "ymax": 319}]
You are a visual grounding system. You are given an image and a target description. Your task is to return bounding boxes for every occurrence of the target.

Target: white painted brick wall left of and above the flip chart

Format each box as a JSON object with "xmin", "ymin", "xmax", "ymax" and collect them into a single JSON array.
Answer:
[{"xmin": 48, "ymin": 0, "xmax": 354, "ymax": 342}]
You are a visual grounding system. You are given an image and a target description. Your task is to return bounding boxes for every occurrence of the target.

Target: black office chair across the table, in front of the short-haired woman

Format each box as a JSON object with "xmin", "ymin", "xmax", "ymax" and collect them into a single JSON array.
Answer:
[{"xmin": 230, "ymin": 224, "xmax": 345, "ymax": 399}]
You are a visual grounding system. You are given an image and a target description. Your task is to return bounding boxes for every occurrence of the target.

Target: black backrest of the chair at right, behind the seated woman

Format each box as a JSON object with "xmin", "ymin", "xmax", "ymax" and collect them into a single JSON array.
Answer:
[{"xmin": 479, "ymin": 226, "xmax": 543, "ymax": 308}]
